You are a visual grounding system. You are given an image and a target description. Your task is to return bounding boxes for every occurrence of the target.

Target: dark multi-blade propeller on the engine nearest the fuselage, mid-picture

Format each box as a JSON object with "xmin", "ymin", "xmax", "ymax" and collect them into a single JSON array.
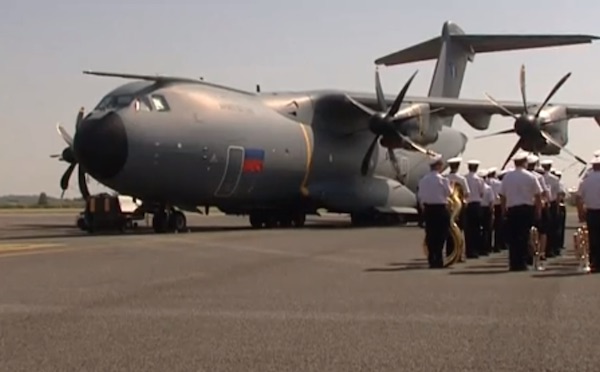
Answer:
[{"xmin": 347, "ymin": 70, "xmax": 437, "ymax": 176}]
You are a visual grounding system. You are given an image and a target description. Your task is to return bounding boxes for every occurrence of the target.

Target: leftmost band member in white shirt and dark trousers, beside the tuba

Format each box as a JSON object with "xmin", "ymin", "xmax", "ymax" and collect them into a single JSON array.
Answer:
[{"xmin": 418, "ymin": 155, "xmax": 452, "ymax": 269}]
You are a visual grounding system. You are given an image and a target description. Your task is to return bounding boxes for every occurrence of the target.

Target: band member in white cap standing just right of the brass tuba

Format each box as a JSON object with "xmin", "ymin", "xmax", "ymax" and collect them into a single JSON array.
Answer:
[{"xmin": 465, "ymin": 160, "xmax": 485, "ymax": 258}]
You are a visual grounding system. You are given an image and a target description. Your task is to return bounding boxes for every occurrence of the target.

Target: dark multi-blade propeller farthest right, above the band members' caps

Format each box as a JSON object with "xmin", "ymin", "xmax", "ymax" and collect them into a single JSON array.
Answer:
[{"xmin": 475, "ymin": 65, "xmax": 587, "ymax": 169}]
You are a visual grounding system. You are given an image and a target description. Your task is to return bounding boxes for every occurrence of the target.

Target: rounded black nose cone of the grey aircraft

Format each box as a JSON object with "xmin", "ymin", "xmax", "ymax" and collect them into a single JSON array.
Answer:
[{"xmin": 73, "ymin": 112, "xmax": 128, "ymax": 179}]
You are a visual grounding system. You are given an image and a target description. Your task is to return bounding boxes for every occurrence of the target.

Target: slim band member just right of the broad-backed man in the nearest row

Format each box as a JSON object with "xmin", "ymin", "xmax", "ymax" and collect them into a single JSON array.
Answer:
[{"xmin": 540, "ymin": 159, "xmax": 563, "ymax": 258}]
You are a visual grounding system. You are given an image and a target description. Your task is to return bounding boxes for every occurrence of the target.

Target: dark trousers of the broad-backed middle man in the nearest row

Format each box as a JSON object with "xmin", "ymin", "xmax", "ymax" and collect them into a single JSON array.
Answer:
[{"xmin": 505, "ymin": 205, "xmax": 535, "ymax": 270}]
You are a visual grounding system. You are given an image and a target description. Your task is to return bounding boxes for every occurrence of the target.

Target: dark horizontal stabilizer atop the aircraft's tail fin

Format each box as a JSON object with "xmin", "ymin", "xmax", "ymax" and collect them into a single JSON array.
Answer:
[{"xmin": 375, "ymin": 21, "xmax": 600, "ymax": 66}]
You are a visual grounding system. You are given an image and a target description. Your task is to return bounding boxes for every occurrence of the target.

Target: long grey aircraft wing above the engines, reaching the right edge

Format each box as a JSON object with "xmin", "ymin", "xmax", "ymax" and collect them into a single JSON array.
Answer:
[{"xmin": 347, "ymin": 92, "xmax": 600, "ymax": 120}]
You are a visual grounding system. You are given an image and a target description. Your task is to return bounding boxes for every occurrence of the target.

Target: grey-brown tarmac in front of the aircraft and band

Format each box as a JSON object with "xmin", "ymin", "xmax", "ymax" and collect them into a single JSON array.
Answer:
[{"xmin": 0, "ymin": 213, "xmax": 600, "ymax": 372}]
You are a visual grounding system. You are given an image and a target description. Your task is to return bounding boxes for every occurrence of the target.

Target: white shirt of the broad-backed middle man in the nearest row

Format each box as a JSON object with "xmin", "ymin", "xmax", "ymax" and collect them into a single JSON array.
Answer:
[{"xmin": 500, "ymin": 168, "xmax": 543, "ymax": 208}]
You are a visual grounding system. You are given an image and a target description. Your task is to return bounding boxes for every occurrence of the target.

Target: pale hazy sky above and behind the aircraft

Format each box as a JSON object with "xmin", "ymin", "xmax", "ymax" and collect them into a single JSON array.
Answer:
[{"xmin": 0, "ymin": 0, "xmax": 600, "ymax": 196}]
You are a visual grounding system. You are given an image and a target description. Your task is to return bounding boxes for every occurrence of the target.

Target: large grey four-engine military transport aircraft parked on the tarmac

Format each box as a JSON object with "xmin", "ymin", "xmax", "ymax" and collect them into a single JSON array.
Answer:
[{"xmin": 52, "ymin": 22, "xmax": 600, "ymax": 232}]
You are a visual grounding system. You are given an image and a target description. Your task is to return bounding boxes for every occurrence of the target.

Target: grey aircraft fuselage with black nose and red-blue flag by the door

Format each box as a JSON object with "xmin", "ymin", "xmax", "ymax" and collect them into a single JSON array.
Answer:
[{"xmin": 74, "ymin": 81, "xmax": 467, "ymax": 213}]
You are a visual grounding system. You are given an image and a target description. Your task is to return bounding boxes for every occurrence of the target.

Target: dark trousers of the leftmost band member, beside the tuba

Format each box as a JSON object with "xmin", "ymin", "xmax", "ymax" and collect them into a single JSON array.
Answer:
[{"xmin": 423, "ymin": 204, "xmax": 450, "ymax": 268}]
